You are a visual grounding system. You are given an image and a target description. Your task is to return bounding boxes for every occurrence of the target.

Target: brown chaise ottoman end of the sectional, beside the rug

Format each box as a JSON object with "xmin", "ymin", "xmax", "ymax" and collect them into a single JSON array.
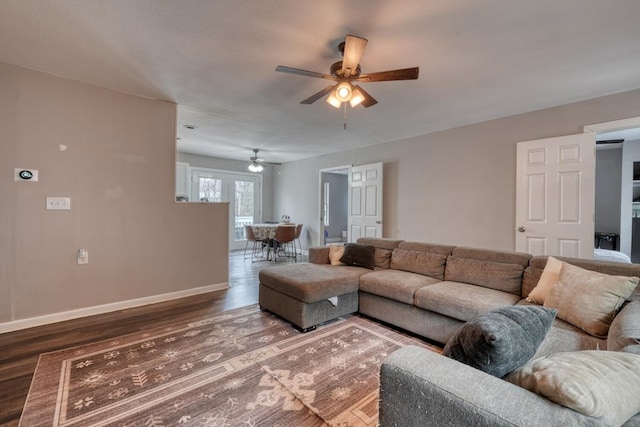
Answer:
[{"xmin": 258, "ymin": 263, "xmax": 364, "ymax": 332}]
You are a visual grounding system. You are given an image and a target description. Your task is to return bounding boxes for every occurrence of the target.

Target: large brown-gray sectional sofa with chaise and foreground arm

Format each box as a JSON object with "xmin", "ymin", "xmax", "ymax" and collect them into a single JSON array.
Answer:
[{"xmin": 260, "ymin": 238, "xmax": 640, "ymax": 426}]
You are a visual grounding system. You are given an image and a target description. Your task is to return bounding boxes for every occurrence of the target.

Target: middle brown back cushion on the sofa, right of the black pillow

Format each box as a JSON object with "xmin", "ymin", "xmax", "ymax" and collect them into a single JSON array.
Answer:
[{"xmin": 390, "ymin": 242, "xmax": 454, "ymax": 280}]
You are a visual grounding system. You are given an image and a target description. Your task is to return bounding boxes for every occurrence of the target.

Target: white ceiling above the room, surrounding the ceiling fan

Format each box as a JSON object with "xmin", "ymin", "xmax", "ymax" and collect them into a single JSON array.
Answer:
[{"xmin": 0, "ymin": 0, "xmax": 640, "ymax": 162}]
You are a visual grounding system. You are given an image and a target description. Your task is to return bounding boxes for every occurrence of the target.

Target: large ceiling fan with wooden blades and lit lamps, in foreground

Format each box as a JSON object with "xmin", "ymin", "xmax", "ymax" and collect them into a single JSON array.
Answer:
[{"xmin": 276, "ymin": 35, "xmax": 419, "ymax": 108}]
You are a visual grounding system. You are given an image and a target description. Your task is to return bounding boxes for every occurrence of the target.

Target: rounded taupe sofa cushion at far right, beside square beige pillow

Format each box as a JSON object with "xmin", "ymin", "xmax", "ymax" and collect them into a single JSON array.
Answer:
[{"xmin": 607, "ymin": 301, "xmax": 640, "ymax": 354}]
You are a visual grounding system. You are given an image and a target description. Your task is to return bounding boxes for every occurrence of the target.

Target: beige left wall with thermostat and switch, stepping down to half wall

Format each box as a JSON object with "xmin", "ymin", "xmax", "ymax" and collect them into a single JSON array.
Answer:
[{"xmin": 0, "ymin": 64, "xmax": 228, "ymax": 324}]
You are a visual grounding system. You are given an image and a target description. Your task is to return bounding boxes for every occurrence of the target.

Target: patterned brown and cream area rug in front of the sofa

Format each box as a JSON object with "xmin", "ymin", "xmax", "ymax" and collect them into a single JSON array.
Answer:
[{"xmin": 20, "ymin": 306, "xmax": 440, "ymax": 427}]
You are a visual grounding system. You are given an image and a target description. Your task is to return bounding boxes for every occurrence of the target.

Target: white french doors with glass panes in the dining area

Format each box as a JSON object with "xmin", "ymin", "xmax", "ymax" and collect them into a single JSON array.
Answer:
[{"xmin": 191, "ymin": 168, "xmax": 262, "ymax": 250}]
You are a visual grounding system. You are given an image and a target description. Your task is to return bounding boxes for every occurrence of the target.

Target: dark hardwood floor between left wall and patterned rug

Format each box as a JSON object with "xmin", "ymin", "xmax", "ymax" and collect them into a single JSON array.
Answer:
[{"xmin": 0, "ymin": 251, "xmax": 307, "ymax": 426}]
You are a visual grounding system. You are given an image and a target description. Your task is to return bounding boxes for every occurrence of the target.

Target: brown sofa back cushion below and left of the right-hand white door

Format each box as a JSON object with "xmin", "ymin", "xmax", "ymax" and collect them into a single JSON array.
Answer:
[{"xmin": 445, "ymin": 255, "xmax": 524, "ymax": 296}]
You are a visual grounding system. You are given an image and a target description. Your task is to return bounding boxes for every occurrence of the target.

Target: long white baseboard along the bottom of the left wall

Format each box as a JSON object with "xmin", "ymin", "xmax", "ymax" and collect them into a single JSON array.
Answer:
[{"xmin": 0, "ymin": 282, "xmax": 229, "ymax": 334}]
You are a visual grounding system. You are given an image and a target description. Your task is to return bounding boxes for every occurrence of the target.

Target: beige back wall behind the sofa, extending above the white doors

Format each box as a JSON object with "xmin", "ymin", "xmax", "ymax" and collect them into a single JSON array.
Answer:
[{"xmin": 274, "ymin": 90, "xmax": 640, "ymax": 250}]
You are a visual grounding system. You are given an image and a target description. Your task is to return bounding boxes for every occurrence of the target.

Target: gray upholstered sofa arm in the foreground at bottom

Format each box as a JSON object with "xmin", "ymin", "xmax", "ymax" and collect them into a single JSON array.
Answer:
[{"xmin": 380, "ymin": 346, "xmax": 602, "ymax": 427}]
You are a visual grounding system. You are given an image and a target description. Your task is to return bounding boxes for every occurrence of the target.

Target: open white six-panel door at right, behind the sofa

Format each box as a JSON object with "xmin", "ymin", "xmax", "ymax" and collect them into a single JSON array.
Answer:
[{"xmin": 515, "ymin": 133, "xmax": 595, "ymax": 258}]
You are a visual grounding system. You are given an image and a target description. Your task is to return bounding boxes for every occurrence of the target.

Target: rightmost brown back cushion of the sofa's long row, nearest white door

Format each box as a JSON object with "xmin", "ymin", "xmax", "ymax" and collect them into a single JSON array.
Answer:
[{"xmin": 445, "ymin": 247, "xmax": 531, "ymax": 295}]
